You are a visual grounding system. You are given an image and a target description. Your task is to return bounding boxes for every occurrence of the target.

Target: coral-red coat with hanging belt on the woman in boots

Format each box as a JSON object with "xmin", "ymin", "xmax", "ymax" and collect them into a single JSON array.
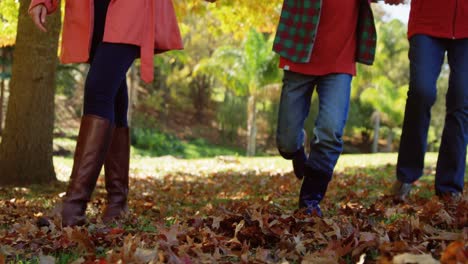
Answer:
[{"xmin": 30, "ymin": 0, "xmax": 183, "ymax": 82}]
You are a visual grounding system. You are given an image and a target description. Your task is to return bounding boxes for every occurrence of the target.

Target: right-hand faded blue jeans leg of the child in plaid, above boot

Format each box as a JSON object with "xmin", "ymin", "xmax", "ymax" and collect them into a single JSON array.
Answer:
[{"xmin": 306, "ymin": 74, "xmax": 352, "ymax": 179}]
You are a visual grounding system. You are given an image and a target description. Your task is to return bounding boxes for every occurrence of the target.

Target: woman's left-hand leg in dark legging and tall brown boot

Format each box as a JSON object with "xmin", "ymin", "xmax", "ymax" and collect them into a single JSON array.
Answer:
[{"xmin": 62, "ymin": 43, "xmax": 139, "ymax": 226}]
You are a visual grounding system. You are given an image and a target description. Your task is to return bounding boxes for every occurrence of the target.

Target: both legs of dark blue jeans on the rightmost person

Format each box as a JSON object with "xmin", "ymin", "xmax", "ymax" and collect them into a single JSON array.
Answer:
[{"xmin": 397, "ymin": 35, "xmax": 468, "ymax": 195}]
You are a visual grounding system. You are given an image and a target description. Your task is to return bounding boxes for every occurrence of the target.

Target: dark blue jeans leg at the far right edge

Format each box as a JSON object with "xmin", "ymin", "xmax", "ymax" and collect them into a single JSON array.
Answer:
[{"xmin": 435, "ymin": 39, "xmax": 468, "ymax": 195}]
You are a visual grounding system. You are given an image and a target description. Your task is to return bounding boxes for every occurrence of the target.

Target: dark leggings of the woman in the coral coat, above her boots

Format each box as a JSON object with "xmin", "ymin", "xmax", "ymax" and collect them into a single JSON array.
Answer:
[{"xmin": 83, "ymin": 0, "xmax": 139, "ymax": 127}]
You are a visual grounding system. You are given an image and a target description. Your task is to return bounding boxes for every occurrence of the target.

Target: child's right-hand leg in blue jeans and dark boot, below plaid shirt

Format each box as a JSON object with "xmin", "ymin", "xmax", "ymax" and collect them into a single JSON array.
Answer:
[{"xmin": 299, "ymin": 74, "xmax": 352, "ymax": 214}]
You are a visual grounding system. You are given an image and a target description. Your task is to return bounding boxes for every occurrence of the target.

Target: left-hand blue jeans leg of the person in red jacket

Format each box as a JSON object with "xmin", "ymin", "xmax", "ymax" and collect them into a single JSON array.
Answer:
[{"xmin": 397, "ymin": 35, "xmax": 446, "ymax": 183}]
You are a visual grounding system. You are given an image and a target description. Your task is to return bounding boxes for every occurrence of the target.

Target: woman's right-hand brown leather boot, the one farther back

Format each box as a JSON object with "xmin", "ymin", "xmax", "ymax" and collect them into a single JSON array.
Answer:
[{"xmin": 102, "ymin": 127, "xmax": 130, "ymax": 223}]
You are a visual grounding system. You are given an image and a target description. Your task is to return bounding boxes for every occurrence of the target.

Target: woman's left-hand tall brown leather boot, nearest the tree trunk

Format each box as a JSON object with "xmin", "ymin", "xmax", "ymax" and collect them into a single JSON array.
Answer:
[{"xmin": 62, "ymin": 115, "xmax": 113, "ymax": 226}]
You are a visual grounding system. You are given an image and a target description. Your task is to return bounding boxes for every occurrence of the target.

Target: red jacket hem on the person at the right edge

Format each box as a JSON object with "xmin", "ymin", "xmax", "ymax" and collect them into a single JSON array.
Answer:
[{"xmin": 408, "ymin": 0, "xmax": 468, "ymax": 39}]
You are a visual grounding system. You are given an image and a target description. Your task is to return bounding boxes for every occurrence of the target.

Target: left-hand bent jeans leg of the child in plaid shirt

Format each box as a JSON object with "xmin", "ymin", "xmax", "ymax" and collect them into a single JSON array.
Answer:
[{"xmin": 276, "ymin": 71, "xmax": 316, "ymax": 159}]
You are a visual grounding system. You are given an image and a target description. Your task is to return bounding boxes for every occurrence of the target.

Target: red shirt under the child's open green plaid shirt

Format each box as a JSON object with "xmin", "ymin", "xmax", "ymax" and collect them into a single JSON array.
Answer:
[{"xmin": 279, "ymin": 0, "xmax": 359, "ymax": 75}]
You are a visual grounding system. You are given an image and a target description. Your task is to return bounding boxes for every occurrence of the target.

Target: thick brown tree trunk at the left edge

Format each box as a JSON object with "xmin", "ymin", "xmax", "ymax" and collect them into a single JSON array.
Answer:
[{"xmin": 0, "ymin": 0, "xmax": 60, "ymax": 185}]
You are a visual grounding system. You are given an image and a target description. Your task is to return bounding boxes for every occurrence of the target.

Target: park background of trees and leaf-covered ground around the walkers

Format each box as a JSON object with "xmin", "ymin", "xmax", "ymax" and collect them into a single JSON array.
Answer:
[{"xmin": 0, "ymin": 0, "xmax": 468, "ymax": 263}]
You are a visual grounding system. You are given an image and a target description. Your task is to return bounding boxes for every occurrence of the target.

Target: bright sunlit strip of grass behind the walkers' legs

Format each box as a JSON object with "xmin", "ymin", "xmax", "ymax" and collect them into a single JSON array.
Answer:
[{"xmin": 54, "ymin": 153, "xmax": 460, "ymax": 184}]
